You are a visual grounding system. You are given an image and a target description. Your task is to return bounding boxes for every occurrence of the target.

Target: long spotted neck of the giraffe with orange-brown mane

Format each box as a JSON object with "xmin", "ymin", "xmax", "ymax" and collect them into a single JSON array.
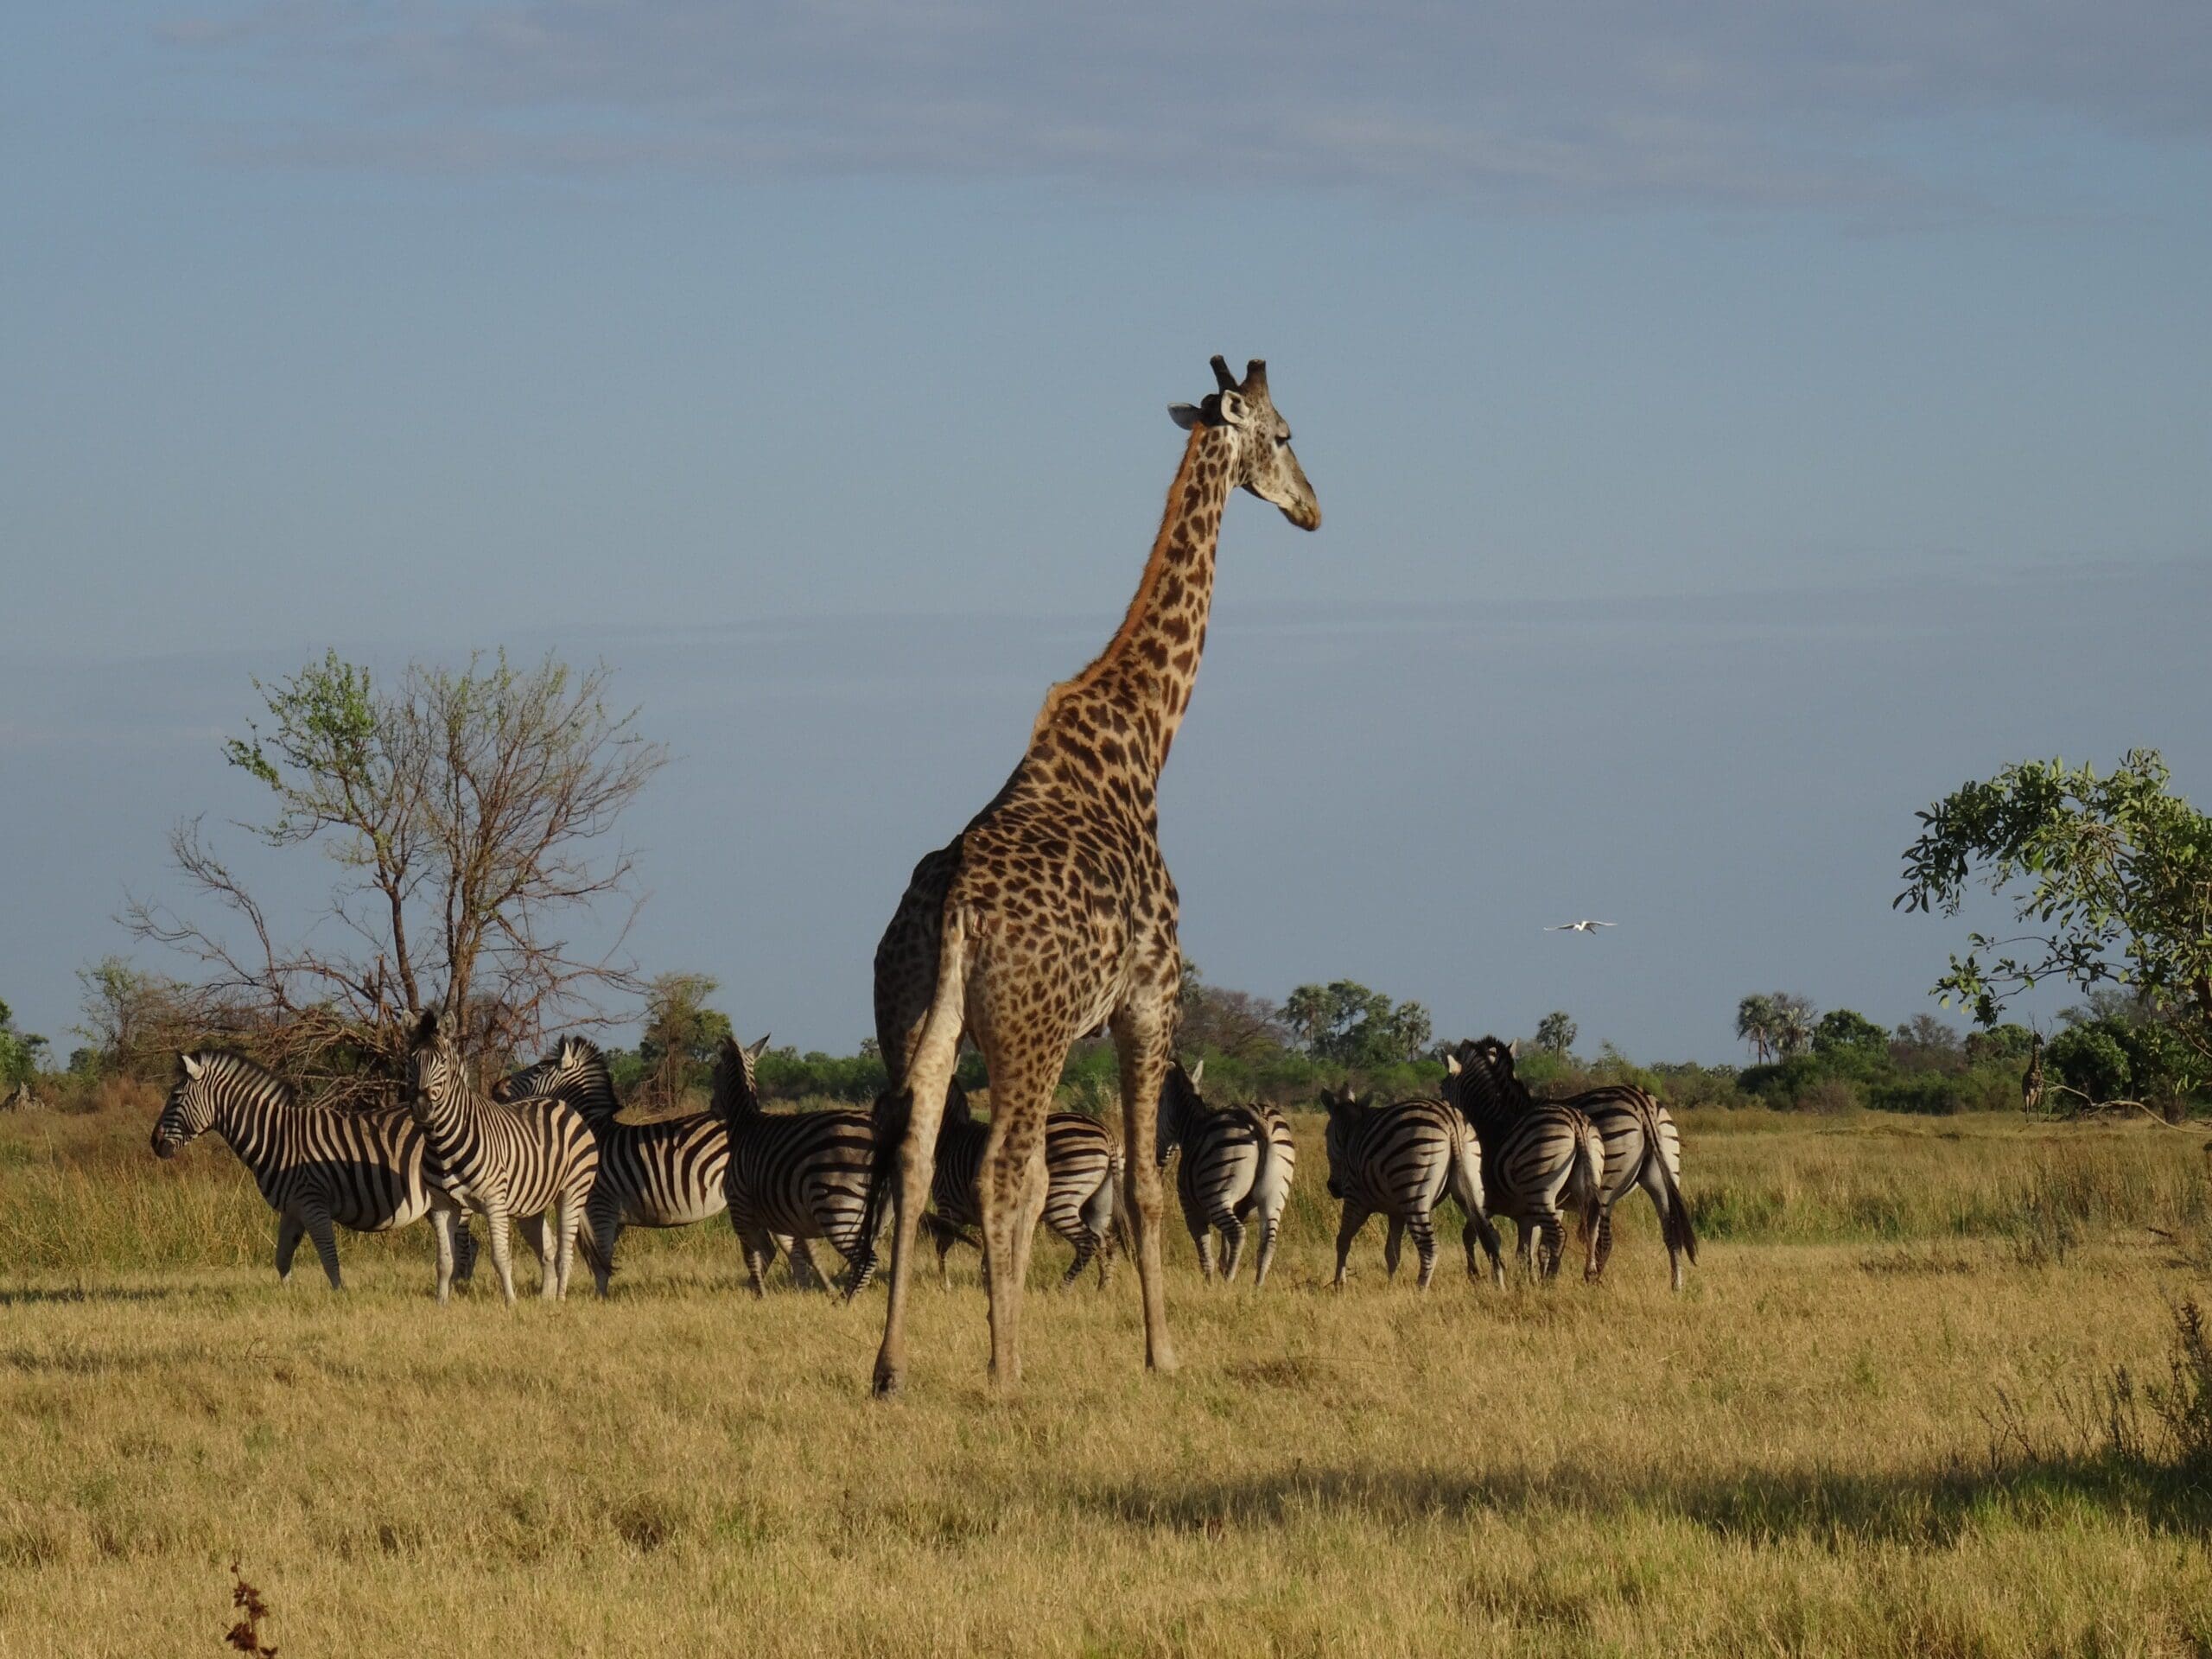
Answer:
[{"xmin": 1057, "ymin": 427, "xmax": 1236, "ymax": 774}]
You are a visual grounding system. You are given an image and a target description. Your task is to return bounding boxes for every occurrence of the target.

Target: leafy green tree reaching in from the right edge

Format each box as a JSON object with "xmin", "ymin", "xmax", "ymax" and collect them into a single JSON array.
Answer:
[{"xmin": 1893, "ymin": 750, "xmax": 2212, "ymax": 1079}]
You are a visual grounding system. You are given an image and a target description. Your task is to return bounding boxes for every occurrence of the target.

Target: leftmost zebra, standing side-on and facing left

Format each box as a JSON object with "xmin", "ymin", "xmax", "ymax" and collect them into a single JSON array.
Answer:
[{"xmin": 153, "ymin": 1048, "xmax": 475, "ymax": 1289}]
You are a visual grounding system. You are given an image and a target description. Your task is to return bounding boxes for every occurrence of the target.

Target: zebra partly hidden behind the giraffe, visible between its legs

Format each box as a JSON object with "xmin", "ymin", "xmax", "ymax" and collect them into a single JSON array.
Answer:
[{"xmin": 923, "ymin": 1082, "xmax": 1128, "ymax": 1289}]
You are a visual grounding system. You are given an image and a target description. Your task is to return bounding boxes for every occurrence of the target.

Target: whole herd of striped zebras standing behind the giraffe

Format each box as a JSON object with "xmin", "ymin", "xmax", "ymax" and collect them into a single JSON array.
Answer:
[{"xmin": 153, "ymin": 1013, "xmax": 1697, "ymax": 1303}]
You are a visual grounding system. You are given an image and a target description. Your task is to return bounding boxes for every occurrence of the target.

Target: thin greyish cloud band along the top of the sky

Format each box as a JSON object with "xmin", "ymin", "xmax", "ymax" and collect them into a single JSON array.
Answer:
[{"xmin": 163, "ymin": 0, "xmax": 2212, "ymax": 214}]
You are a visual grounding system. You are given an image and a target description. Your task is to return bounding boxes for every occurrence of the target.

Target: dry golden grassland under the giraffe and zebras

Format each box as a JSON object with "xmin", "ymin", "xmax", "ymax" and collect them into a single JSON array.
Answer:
[{"xmin": 0, "ymin": 1102, "xmax": 2212, "ymax": 1659}]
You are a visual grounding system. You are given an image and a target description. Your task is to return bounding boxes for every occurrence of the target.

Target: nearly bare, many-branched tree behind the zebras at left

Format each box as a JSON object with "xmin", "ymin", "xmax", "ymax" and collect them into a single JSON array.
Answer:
[{"xmin": 122, "ymin": 652, "xmax": 666, "ymax": 1097}]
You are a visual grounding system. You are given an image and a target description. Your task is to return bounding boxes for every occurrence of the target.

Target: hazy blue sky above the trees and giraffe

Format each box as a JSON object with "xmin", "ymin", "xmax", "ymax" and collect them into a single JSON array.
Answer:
[{"xmin": 0, "ymin": 0, "xmax": 2212, "ymax": 1058}]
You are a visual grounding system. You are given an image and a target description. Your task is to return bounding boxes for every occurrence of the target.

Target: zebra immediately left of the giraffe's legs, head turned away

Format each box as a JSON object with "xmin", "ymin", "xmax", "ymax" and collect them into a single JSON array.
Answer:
[{"xmin": 715, "ymin": 1038, "xmax": 878, "ymax": 1300}]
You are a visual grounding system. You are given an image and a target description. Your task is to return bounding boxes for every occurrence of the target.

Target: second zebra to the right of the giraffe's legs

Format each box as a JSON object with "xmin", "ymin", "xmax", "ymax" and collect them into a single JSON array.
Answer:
[{"xmin": 1320, "ymin": 1089, "xmax": 1504, "ymax": 1289}]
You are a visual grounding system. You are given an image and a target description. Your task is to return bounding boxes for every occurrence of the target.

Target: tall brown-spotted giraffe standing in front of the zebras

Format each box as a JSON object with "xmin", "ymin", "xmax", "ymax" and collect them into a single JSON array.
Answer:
[{"xmin": 874, "ymin": 356, "xmax": 1320, "ymax": 1394}]
